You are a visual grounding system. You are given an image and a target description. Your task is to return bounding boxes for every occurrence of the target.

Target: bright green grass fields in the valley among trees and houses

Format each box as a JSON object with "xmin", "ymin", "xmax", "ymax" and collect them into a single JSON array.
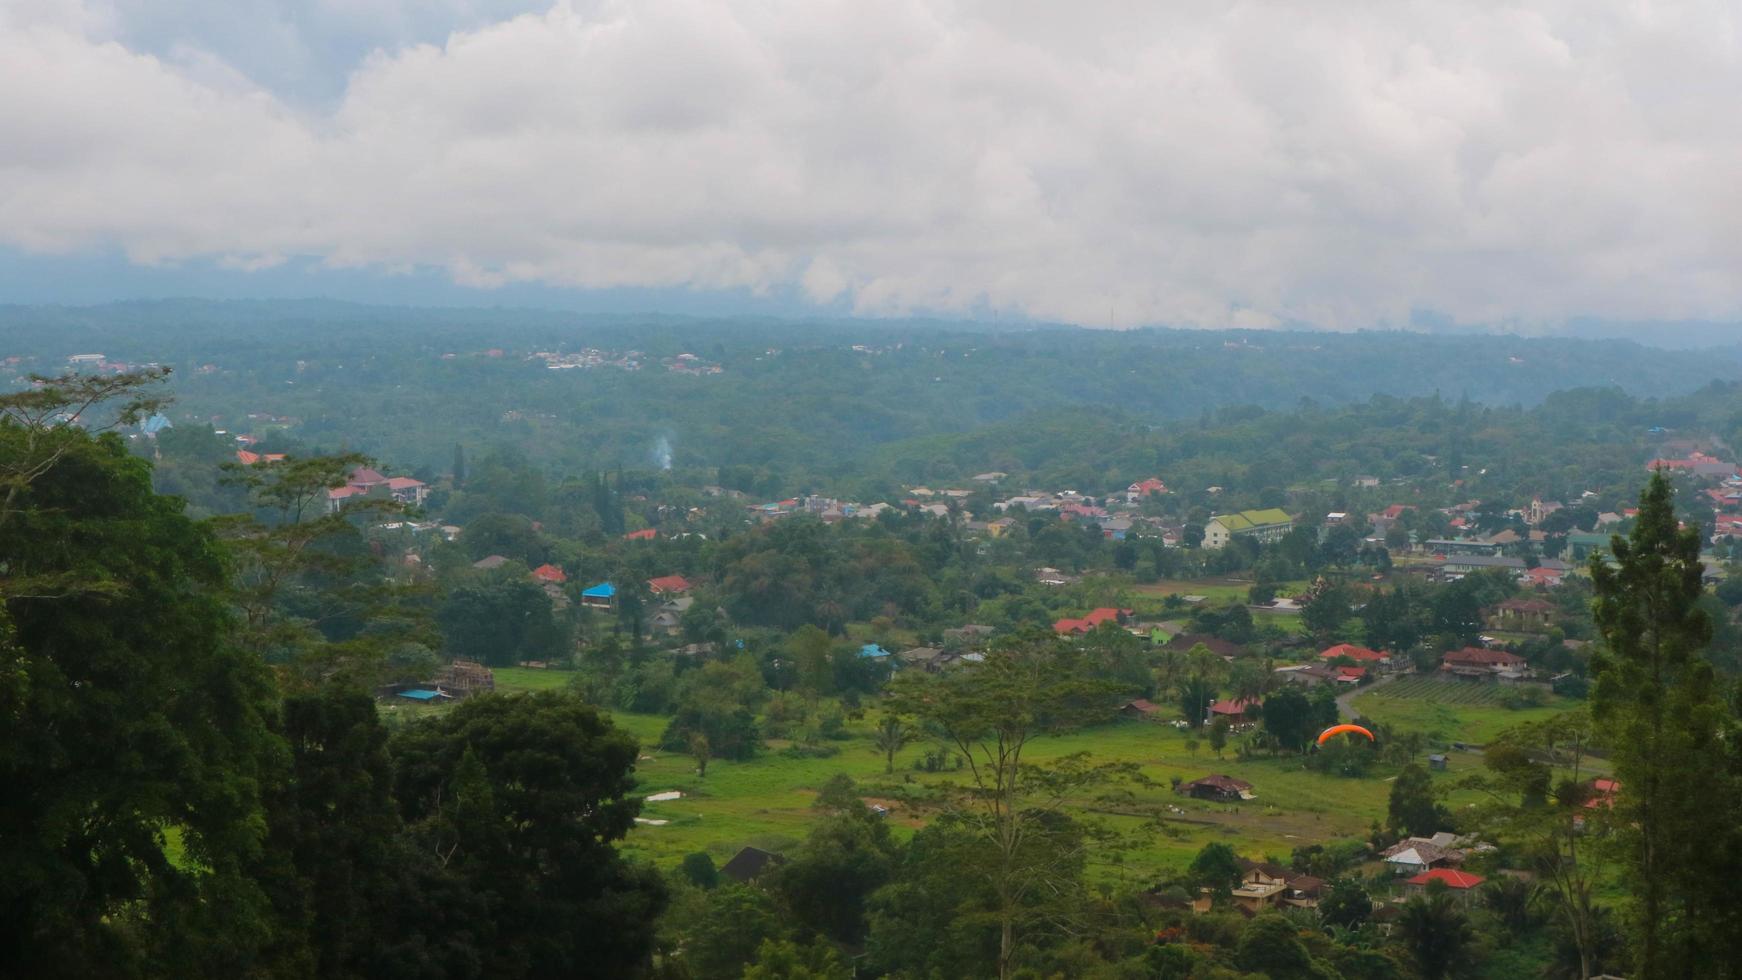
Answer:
[{"xmin": 414, "ymin": 667, "xmax": 1564, "ymax": 881}]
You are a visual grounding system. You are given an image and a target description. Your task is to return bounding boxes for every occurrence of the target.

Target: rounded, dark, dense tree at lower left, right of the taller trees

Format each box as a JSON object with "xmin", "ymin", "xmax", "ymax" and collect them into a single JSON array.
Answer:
[{"xmin": 392, "ymin": 691, "xmax": 665, "ymax": 977}]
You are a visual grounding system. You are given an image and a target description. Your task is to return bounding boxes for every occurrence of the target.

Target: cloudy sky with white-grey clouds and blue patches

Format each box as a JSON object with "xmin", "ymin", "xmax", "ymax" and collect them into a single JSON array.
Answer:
[{"xmin": 0, "ymin": 0, "xmax": 1742, "ymax": 327}]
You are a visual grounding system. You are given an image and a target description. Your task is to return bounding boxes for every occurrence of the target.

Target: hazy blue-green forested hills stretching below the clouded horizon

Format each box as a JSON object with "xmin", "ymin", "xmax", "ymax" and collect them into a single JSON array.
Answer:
[{"xmin": 0, "ymin": 301, "xmax": 1742, "ymax": 482}]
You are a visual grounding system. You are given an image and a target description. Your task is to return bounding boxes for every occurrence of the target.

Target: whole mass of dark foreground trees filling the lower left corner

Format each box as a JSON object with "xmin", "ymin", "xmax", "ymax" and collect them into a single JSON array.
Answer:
[{"xmin": 0, "ymin": 378, "xmax": 664, "ymax": 978}]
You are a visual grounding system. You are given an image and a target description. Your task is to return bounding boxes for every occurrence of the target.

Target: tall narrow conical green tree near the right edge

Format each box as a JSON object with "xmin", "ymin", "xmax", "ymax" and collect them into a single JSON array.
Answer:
[{"xmin": 1590, "ymin": 472, "xmax": 1742, "ymax": 978}]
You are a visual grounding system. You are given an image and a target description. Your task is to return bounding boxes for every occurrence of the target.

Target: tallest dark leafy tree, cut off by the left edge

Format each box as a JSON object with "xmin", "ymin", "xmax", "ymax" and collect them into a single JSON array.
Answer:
[{"xmin": 0, "ymin": 417, "xmax": 279, "ymax": 975}]
